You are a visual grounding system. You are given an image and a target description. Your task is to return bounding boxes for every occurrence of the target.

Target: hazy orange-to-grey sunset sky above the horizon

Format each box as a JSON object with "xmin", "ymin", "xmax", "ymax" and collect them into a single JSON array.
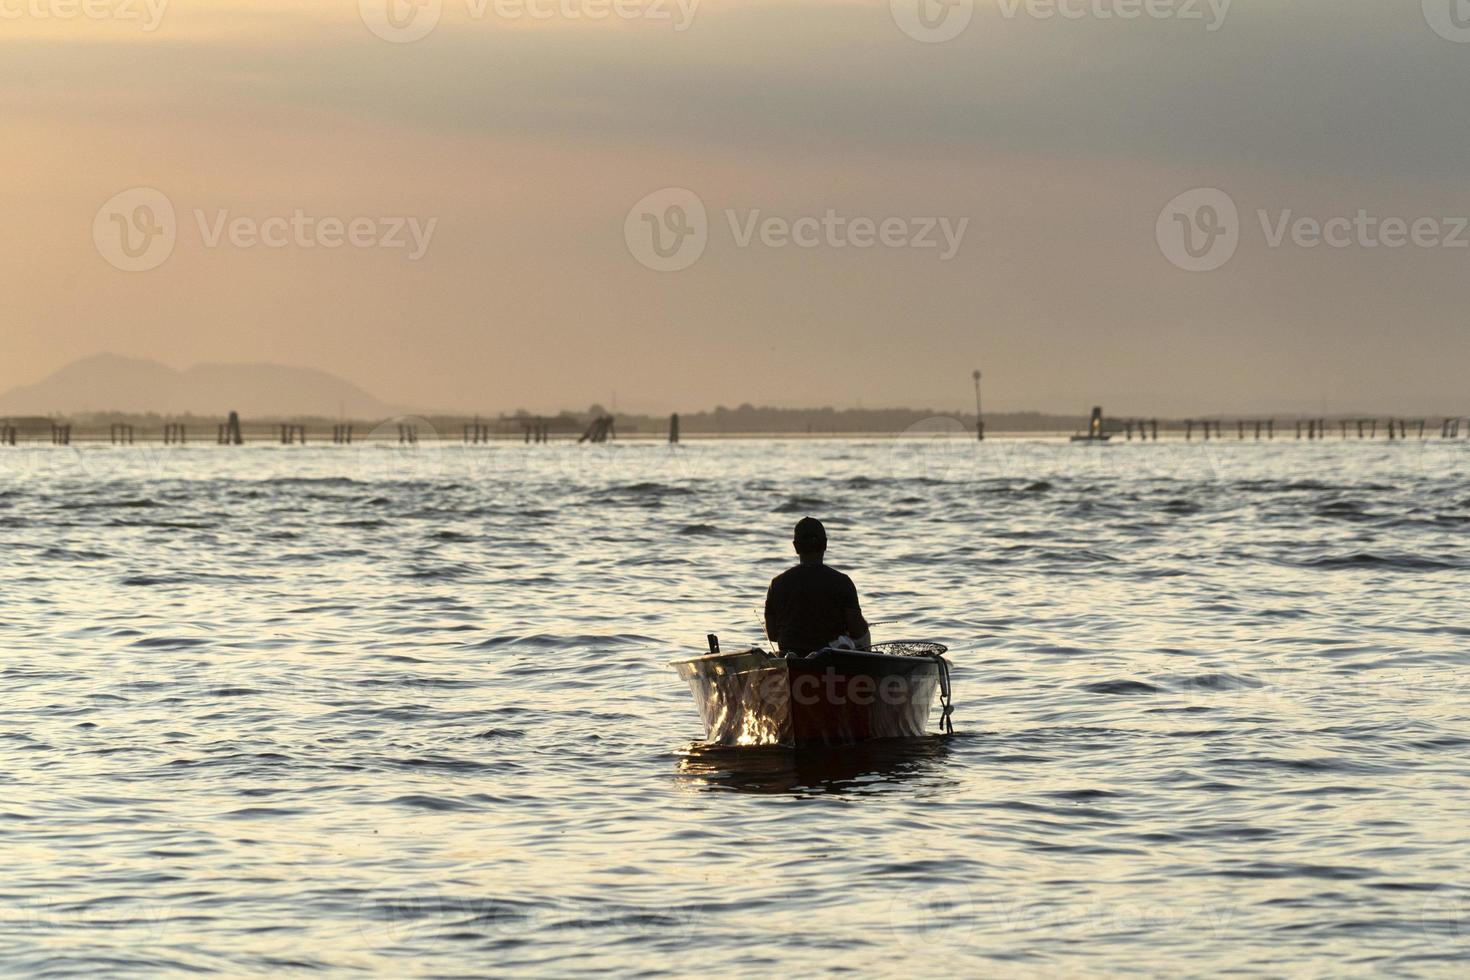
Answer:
[{"xmin": 0, "ymin": 0, "xmax": 1470, "ymax": 414}]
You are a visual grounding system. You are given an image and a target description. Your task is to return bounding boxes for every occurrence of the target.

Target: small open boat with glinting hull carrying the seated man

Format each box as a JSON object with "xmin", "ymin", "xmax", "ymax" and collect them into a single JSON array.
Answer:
[{"xmin": 669, "ymin": 636, "xmax": 954, "ymax": 746}]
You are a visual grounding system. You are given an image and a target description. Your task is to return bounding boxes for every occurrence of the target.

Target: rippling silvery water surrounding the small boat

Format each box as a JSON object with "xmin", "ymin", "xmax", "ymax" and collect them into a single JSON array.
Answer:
[{"xmin": 0, "ymin": 439, "xmax": 1470, "ymax": 977}]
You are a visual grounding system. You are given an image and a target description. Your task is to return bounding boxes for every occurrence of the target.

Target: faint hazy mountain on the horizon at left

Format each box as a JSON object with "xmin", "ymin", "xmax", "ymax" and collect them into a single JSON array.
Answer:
[{"xmin": 0, "ymin": 354, "xmax": 400, "ymax": 419}]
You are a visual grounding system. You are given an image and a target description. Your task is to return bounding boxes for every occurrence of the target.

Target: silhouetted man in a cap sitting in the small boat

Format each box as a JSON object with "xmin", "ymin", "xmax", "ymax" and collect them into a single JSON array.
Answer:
[{"xmin": 766, "ymin": 517, "xmax": 869, "ymax": 654}]
